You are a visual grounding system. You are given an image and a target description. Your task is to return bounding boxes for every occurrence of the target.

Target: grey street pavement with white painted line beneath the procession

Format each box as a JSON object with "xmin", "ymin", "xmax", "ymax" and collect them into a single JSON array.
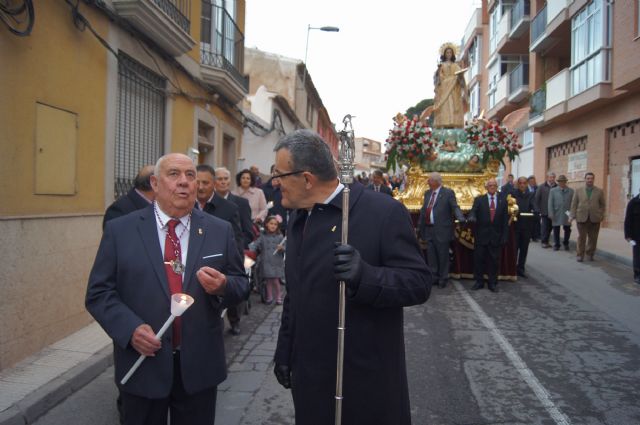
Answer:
[{"xmin": 5, "ymin": 238, "xmax": 640, "ymax": 425}]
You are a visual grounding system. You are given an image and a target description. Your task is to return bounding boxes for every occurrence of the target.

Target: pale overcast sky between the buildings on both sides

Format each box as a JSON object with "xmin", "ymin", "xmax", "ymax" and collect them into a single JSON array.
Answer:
[{"xmin": 245, "ymin": 0, "xmax": 480, "ymax": 142}]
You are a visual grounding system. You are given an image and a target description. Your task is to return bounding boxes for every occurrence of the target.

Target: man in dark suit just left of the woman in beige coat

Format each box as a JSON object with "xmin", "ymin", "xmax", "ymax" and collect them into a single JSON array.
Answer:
[{"xmin": 214, "ymin": 167, "xmax": 254, "ymax": 335}]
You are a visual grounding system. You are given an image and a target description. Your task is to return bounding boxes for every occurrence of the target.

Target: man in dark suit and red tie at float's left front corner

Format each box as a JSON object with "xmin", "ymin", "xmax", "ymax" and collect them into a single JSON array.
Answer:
[{"xmin": 418, "ymin": 172, "xmax": 466, "ymax": 288}]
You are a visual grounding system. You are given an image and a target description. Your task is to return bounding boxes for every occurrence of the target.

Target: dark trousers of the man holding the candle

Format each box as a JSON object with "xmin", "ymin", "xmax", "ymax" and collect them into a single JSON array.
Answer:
[{"xmin": 121, "ymin": 352, "xmax": 217, "ymax": 425}]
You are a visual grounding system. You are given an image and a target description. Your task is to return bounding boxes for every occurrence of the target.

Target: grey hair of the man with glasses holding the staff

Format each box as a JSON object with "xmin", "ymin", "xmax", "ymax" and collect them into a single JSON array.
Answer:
[{"xmin": 273, "ymin": 129, "xmax": 338, "ymax": 181}]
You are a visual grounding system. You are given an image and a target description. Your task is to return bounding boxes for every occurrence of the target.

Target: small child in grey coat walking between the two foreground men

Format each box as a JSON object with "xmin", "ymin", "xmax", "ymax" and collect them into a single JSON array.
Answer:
[{"xmin": 249, "ymin": 215, "xmax": 285, "ymax": 304}]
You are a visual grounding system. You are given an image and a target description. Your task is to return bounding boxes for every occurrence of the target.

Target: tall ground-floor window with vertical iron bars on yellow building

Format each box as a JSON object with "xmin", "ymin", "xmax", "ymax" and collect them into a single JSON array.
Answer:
[{"xmin": 114, "ymin": 52, "xmax": 165, "ymax": 197}]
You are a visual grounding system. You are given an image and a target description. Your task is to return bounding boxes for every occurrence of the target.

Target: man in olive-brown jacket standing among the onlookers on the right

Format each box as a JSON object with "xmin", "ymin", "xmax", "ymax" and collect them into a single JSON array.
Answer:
[{"xmin": 570, "ymin": 172, "xmax": 605, "ymax": 262}]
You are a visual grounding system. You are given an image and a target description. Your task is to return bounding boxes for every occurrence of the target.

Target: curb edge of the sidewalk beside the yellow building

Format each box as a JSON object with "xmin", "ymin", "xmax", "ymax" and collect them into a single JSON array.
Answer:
[{"xmin": 0, "ymin": 344, "xmax": 113, "ymax": 425}]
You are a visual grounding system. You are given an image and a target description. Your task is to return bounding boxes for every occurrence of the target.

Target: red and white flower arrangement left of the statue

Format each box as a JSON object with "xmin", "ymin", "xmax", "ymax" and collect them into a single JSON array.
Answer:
[{"xmin": 384, "ymin": 113, "xmax": 439, "ymax": 171}]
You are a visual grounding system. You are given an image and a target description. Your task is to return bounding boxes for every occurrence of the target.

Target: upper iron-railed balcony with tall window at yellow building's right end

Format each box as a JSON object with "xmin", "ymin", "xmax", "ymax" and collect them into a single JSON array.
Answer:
[{"xmin": 200, "ymin": 0, "xmax": 249, "ymax": 91}]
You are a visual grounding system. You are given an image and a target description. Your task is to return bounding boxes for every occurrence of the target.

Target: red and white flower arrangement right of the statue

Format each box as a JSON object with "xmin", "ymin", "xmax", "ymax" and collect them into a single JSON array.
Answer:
[{"xmin": 464, "ymin": 119, "xmax": 522, "ymax": 165}]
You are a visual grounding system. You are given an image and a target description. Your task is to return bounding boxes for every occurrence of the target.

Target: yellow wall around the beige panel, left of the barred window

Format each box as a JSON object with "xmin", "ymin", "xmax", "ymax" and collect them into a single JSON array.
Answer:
[{"xmin": 0, "ymin": 1, "xmax": 107, "ymax": 217}]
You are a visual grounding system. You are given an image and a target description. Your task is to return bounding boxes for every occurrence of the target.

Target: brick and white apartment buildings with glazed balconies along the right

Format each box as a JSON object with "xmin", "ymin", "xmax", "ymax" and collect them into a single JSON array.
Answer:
[{"xmin": 462, "ymin": 0, "xmax": 640, "ymax": 229}]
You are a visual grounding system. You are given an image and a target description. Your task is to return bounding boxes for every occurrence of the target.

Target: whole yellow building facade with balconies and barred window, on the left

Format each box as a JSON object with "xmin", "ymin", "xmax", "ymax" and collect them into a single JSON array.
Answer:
[{"xmin": 0, "ymin": 0, "xmax": 248, "ymax": 369}]
